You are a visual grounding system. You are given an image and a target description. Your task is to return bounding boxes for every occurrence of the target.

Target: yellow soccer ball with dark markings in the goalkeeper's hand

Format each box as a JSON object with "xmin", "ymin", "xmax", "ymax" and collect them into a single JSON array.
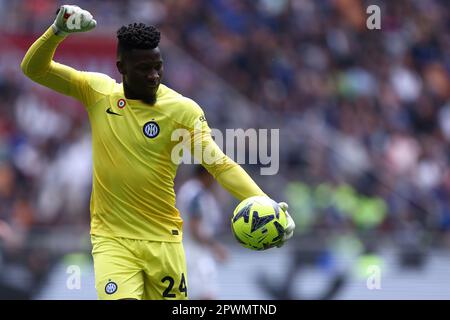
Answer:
[{"xmin": 231, "ymin": 196, "xmax": 287, "ymax": 250}]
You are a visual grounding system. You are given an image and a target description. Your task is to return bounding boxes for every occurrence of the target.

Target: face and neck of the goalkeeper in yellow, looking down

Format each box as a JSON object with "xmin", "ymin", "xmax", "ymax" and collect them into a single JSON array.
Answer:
[{"xmin": 116, "ymin": 47, "xmax": 163, "ymax": 105}]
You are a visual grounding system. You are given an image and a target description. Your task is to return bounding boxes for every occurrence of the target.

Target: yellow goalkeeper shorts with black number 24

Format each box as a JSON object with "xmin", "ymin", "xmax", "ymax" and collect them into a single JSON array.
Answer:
[{"xmin": 91, "ymin": 235, "xmax": 188, "ymax": 300}]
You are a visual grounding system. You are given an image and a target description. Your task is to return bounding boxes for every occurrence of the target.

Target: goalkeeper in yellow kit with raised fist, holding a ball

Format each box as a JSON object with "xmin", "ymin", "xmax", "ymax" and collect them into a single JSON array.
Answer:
[{"xmin": 21, "ymin": 5, "xmax": 294, "ymax": 299}]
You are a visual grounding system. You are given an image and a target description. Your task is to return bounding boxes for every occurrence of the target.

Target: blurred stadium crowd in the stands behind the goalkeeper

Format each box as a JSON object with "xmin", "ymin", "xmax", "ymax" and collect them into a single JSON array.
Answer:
[{"xmin": 0, "ymin": 0, "xmax": 450, "ymax": 298}]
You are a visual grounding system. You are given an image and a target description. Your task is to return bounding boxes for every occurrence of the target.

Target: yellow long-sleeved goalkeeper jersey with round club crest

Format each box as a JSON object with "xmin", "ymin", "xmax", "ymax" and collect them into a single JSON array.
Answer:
[{"xmin": 21, "ymin": 28, "xmax": 264, "ymax": 242}]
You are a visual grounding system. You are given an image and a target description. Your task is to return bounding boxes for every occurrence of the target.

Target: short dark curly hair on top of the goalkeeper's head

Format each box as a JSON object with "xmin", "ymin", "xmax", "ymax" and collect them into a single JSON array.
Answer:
[{"xmin": 117, "ymin": 23, "xmax": 161, "ymax": 53}]
